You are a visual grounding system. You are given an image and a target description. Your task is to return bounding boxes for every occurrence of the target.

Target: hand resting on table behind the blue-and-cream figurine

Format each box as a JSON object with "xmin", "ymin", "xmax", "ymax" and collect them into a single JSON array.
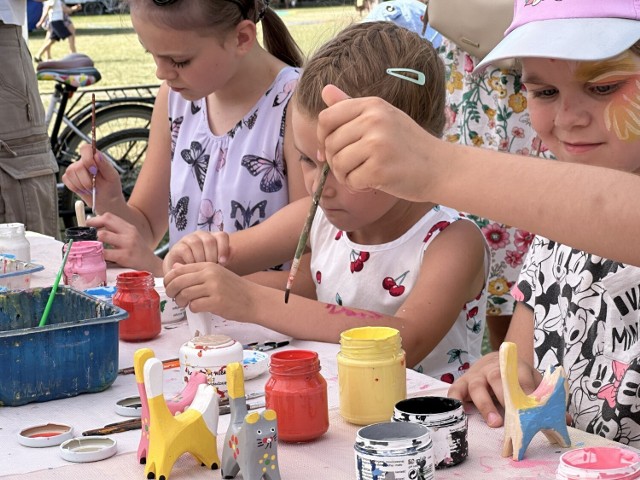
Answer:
[{"xmin": 448, "ymin": 352, "xmax": 542, "ymax": 428}]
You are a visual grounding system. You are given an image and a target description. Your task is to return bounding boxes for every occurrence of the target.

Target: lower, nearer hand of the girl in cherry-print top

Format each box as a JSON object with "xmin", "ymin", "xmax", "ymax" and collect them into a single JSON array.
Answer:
[{"xmin": 164, "ymin": 263, "xmax": 259, "ymax": 321}]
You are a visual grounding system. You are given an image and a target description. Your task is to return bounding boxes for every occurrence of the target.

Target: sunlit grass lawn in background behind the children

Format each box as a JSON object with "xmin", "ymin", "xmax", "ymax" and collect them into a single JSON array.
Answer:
[{"xmin": 29, "ymin": 5, "xmax": 359, "ymax": 95}]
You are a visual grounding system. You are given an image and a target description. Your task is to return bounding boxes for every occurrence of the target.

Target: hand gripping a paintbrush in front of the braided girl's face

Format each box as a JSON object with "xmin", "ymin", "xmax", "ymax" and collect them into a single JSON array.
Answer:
[{"xmin": 318, "ymin": 85, "xmax": 444, "ymax": 201}]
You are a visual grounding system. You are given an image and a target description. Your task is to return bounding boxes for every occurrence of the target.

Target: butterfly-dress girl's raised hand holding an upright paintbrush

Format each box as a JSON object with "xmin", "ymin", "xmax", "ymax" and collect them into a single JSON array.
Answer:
[{"xmin": 62, "ymin": 144, "xmax": 124, "ymax": 207}]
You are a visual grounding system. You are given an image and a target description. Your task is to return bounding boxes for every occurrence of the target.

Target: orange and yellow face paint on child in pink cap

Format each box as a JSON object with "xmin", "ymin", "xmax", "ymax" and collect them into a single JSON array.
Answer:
[{"xmin": 576, "ymin": 51, "xmax": 640, "ymax": 142}]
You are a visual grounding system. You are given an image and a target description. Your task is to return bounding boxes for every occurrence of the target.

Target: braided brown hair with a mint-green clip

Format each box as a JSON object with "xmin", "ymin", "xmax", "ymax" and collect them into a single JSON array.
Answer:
[{"xmin": 295, "ymin": 21, "xmax": 445, "ymax": 137}]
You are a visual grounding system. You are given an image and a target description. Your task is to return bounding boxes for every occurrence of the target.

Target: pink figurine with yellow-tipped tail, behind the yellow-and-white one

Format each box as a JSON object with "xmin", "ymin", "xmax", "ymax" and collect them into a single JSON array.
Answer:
[{"xmin": 133, "ymin": 348, "xmax": 207, "ymax": 464}]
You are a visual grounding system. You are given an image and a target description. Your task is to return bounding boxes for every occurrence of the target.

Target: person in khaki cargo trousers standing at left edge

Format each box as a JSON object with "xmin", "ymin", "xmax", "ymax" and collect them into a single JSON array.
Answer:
[{"xmin": 0, "ymin": 0, "xmax": 58, "ymax": 237}]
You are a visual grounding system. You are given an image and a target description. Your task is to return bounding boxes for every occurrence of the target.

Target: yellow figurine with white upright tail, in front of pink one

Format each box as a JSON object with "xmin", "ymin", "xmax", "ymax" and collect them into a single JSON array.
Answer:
[{"xmin": 143, "ymin": 358, "xmax": 220, "ymax": 480}]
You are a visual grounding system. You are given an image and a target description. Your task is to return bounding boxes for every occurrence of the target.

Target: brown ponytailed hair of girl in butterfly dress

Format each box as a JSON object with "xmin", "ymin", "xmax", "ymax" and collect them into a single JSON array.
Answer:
[{"xmin": 127, "ymin": 0, "xmax": 303, "ymax": 67}]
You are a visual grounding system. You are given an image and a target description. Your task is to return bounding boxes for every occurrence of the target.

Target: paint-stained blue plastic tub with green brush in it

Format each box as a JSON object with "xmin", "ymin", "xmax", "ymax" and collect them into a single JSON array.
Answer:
[{"xmin": 0, "ymin": 286, "xmax": 127, "ymax": 406}]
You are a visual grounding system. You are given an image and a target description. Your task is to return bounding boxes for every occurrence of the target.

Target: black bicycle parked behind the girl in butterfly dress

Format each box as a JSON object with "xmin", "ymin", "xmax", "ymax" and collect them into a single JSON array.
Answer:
[{"xmin": 37, "ymin": 54, "xmax": 166, "ymax": 254}]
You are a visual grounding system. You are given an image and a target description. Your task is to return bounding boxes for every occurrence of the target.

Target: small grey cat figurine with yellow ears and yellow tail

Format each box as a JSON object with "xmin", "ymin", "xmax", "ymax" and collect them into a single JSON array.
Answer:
[{"xmin": 220, "ymin": 362, "xmax": 280, "ymax": 480}]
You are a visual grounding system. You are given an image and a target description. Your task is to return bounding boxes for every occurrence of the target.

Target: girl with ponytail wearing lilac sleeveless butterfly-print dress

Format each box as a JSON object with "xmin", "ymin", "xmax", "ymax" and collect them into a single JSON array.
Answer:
[{"xmin": 63, "ymin": 0, "xmax": 306, "ymax": 276}]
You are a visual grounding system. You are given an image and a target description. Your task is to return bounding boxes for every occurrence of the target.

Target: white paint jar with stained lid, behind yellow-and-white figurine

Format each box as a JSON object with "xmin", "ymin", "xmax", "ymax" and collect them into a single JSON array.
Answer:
[{"xmin": 180, "ymin": 335, "xmax": 243, "ymax": 398}]
